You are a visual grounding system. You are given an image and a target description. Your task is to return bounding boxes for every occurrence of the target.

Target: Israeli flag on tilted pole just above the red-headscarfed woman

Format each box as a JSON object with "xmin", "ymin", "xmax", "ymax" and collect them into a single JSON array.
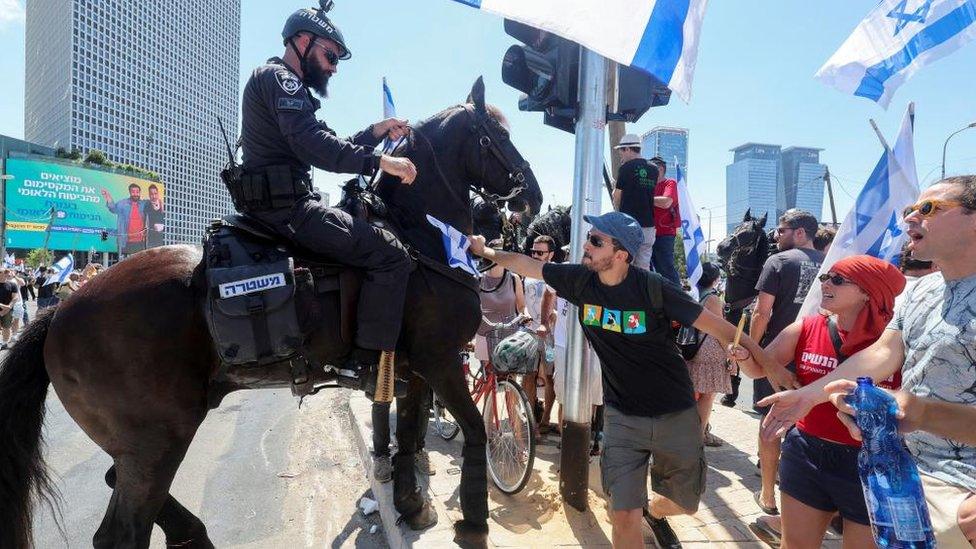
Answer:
[{"xmin": 797, "ymin": 103, "xmax": 919, "ymax": 318}]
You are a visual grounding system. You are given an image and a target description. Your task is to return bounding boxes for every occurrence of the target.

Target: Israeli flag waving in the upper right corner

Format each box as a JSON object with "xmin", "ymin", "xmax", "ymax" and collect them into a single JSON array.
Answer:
[{"xmin": 816, "ymin": 0, "xmax": 976, "ymax": 108}]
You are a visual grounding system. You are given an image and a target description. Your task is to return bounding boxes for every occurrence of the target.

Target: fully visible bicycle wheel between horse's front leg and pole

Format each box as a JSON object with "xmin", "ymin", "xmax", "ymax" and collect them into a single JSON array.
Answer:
[{"xmin": 482, "ymin": 379, "xmax": 535, "ymax": 494}]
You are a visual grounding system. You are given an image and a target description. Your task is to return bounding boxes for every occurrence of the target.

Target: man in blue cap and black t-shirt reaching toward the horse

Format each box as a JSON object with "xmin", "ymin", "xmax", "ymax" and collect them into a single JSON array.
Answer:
[{"xmin": 470, "ymin": 212, "xmax": 792, "ymax": 547}]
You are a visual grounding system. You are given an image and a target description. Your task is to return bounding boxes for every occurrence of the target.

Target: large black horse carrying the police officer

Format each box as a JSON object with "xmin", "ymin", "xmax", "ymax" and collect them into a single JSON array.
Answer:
[{"xmin": 0, "ymin": 79, "xmax": 542, "ymax": 549}]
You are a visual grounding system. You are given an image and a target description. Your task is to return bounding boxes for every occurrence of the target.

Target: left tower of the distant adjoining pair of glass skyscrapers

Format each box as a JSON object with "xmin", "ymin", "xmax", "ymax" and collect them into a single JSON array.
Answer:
[{"xmin": 725, "ymin": 143, "xmax": 782, "ymax": 233}]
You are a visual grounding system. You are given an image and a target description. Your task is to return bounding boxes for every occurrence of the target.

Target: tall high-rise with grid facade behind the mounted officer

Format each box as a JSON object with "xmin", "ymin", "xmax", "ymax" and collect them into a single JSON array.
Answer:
[{"xmin": 24, "ymin": 0, "xmax": 241, "ymax": 244}]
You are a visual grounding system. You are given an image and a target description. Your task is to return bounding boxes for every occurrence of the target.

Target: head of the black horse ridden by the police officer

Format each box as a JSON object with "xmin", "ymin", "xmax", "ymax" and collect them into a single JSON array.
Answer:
[{"xmin": 462, "ymin": 76, "xmax": 542, "ymax": 215}]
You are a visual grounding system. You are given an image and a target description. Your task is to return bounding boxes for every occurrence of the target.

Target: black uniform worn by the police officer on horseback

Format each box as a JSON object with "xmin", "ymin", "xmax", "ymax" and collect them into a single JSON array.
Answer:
[{"xmin": 244, "ymin": 58, "xmax": 414, "ymax": 350}]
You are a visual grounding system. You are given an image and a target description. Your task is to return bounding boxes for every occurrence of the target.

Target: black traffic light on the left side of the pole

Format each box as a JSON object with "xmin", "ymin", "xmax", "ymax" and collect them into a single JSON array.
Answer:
[{"xmin": 502, "ymin": 19, "xmax": 580, "ymax": 132}]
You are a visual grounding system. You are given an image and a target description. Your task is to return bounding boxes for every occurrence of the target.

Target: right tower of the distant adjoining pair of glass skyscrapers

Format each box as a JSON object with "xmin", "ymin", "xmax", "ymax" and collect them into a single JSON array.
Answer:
[{"xmin": 776, "ymin": 147, "xmax": 827, "ymax": 220}]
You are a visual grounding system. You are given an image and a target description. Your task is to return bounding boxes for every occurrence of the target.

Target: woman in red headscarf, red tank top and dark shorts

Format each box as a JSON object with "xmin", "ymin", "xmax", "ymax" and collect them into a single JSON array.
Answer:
[{"xmin": 729, "ymin": 255, "xmax": 905, "ymax": 547}]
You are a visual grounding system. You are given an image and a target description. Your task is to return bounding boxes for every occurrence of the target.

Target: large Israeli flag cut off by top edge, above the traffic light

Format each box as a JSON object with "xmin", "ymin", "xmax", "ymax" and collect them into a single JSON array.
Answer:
[{"xmin": 455, "ymin": 0, "xmax": 708, "ymax": 103}]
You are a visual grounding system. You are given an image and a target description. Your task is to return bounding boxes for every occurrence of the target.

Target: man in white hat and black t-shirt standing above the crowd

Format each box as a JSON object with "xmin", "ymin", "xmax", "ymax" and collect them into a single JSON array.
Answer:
[{"xmin": 613, "ymin": 134, "xmax": 670, "ymax": 271}]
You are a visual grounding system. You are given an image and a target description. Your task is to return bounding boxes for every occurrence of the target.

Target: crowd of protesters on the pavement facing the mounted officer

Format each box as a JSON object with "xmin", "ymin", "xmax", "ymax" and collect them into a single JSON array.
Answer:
[{"xmin": 471, "ymin": 156, "xmax": 976, "ymax": 548}]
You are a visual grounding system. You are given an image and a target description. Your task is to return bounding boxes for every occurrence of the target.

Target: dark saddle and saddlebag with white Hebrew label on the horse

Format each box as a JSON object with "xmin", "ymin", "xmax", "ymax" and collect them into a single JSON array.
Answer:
[{"xmin": 203, "ymin": 214, "xmax": 363, "ymax": 397}]
